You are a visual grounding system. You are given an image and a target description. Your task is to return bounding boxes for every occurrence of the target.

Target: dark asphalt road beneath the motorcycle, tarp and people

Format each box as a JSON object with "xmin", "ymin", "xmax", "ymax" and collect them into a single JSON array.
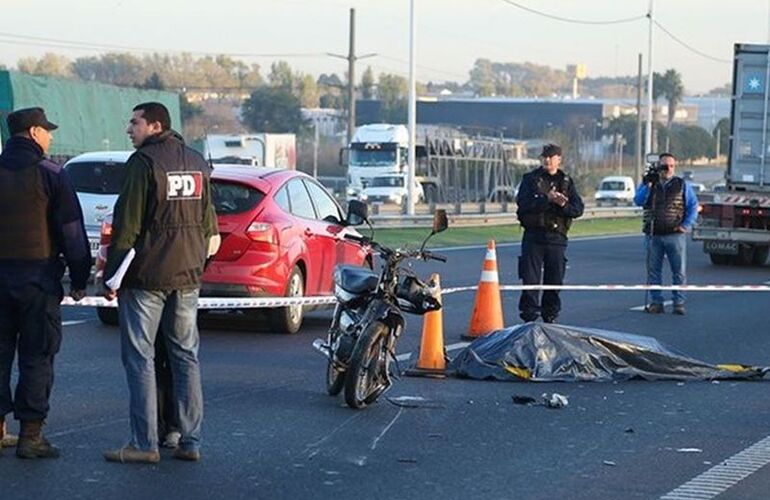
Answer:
[{"xmin": 0, "ymin": 236, "xmax": 770, "ymax": 499}]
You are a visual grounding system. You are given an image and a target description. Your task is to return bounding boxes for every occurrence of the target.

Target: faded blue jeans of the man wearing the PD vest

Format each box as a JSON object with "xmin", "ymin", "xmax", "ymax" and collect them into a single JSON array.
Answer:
[{"xmin": 118, "ymin": 288, "xmax": 203, "ymax": 451}]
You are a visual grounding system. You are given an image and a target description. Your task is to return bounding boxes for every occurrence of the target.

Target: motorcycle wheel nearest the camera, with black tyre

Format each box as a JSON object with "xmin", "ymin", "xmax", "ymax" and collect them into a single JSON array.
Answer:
[{"xmin": 345, "ymin": 321, "xmax": 390, "ymax": 410}]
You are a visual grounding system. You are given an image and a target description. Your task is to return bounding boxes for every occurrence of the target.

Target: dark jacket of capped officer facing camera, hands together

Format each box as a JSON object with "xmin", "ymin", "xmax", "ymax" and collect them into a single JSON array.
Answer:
[{"xmin": 516, "ymin": 167, "xmax": 583, "ymax": 245}]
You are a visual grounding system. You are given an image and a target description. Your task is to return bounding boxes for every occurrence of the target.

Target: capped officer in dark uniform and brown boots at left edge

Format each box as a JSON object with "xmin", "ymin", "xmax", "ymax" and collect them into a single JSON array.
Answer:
[{"xmin": 0, "ymin": 108, "xmax": 91, "ymax": 458}]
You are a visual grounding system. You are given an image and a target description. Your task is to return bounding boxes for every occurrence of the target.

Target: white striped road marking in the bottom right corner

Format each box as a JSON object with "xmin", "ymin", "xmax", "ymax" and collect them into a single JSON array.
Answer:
[{"xmin": 660, "ymin": 436, "xmax": 770, "ymax": 500}]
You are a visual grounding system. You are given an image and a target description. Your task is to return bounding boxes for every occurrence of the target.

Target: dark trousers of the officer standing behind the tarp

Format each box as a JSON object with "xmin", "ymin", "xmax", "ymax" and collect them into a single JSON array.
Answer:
[{"xmin": 519, "ymin": 241, "xmax": 567, "ymax": 321}]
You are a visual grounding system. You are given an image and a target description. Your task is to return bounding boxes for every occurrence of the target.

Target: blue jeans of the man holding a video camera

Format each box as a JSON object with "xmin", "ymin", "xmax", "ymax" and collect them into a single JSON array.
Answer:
[{"xmin": 644, "ymin": 233, "xmax": 687, "ymax": 305}]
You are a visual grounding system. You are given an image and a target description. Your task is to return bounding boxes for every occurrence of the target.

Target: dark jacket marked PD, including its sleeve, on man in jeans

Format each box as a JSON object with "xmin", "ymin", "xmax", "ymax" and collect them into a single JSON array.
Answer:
[{"xmin": 104, "ymin": 131, "xmax": 218, "ymax": 290}]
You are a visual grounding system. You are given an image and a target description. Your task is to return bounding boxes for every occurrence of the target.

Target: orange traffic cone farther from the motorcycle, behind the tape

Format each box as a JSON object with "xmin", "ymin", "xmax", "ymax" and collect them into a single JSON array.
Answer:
[{"xmin": 463, "ymin": 240, "xmax": 504, "ymax": 339}]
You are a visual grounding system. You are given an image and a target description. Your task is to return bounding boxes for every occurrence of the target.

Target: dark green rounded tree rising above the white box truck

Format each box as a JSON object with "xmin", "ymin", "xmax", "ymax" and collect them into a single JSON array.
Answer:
[{"xmin": 241, "ymin": 86, "xmax": 305, "ymax": 133}]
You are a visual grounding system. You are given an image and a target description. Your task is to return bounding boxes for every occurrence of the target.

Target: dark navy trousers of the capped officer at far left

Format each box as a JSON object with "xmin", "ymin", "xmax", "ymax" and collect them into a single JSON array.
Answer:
[{"xmin": 0, "ymin": 284, "xmax": 61, "ymax": 420}]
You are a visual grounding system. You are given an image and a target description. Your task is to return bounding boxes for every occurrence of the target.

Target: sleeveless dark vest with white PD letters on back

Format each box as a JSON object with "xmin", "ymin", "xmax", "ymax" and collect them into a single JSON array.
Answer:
[{"xmin": 124, "ymin": 133, "xmax": 210, "ymax": 290}]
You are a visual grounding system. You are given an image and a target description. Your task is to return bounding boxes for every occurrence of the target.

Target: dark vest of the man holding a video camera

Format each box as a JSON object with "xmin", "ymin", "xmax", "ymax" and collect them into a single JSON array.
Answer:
[{"xmin": 644, "ymin": 177, "xmax": 684, "ymax": 235}]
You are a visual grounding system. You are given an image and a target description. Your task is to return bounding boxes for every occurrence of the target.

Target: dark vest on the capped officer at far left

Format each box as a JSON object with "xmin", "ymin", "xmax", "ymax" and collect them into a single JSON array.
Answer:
[{"xmin": 0, "ymin": 163, "xmax": 54, "ymax": 260}]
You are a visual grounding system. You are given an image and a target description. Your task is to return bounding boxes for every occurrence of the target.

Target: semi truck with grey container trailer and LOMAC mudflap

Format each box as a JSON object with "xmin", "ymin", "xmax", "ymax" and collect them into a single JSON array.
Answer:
[{"xmin": 693, "ymin": 43, "xmax": 770, "ymax": 266}]
